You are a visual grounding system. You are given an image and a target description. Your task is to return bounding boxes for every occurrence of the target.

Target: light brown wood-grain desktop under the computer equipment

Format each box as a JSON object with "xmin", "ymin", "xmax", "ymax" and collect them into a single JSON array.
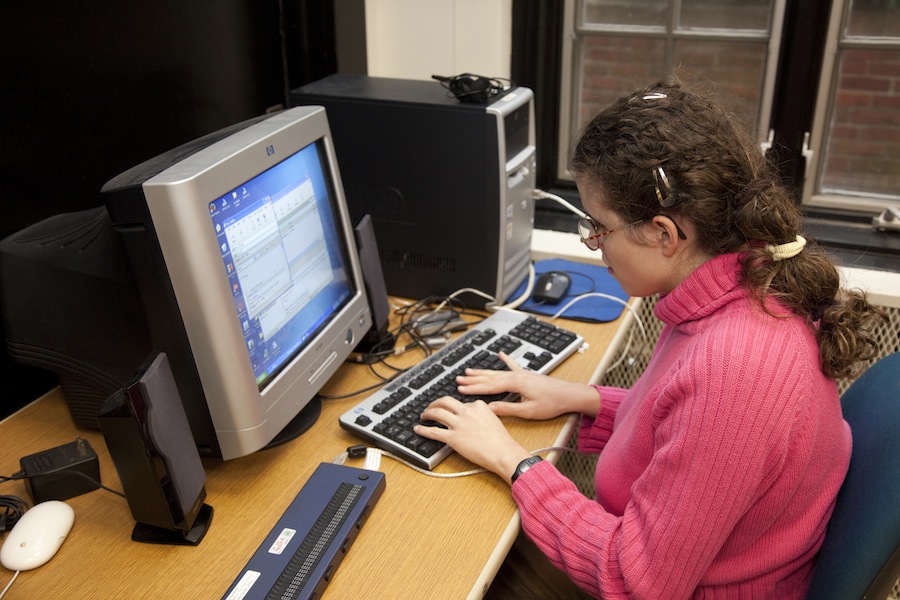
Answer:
[{"xmin": 0, "ymin": 311, "xmax": 630, "ymax": 600}]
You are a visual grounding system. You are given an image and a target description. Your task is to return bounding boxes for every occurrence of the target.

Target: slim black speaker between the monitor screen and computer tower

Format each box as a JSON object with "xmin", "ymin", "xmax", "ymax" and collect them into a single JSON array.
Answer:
[{"xmin": 354, "ymin": 214, "xmax": 396, "ymax": 352}]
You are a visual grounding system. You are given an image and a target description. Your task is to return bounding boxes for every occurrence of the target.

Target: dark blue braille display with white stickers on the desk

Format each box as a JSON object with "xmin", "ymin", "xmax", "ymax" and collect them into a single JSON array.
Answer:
[{"xmin": 223, "ymin": 463, "xmax": 385, "ymax": 600}]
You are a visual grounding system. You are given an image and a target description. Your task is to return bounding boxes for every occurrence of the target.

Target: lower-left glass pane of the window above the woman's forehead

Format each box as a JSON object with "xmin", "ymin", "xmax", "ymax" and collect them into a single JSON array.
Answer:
[{"xmin": 572, "ymin": 35, "xmax": 666, "ymax": 133}]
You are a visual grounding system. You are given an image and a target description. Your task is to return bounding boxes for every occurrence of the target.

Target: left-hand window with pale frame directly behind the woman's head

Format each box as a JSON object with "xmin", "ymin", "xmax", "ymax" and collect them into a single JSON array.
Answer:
[{"xmin": 557, "ymin": 0, "xmax": 784, "ymax": 179}]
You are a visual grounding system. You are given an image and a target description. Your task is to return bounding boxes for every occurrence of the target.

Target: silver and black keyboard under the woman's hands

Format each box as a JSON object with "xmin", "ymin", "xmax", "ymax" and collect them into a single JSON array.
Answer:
[{"xmin": 340, "ymin": 310, "xmax": 584, "ymax": 470}]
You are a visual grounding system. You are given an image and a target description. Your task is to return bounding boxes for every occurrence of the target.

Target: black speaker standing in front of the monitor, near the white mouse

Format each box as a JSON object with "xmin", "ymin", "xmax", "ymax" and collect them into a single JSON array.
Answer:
[{"xmin": 97, "ymin": 352, "xmax": 213, "ymax": 545}]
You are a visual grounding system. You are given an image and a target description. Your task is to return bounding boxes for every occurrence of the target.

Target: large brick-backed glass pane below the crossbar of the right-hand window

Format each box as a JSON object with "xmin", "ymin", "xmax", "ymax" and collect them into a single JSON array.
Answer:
[{"xmin": 821, "ymin": 49, "xmax": 900, "ymax": 197}]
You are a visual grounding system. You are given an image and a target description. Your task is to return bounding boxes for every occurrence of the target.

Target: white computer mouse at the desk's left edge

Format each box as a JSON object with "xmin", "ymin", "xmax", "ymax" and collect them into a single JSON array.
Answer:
[{"xmin": 0, "ymin": 500, "xmax": 75, "ymax": 571}]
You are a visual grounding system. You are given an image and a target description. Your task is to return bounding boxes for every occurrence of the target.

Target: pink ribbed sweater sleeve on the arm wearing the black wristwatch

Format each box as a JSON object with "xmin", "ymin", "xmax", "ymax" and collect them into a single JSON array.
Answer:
[{"xmin": 512, "ymin": 338, "xmax": 795, "ymax": 600}]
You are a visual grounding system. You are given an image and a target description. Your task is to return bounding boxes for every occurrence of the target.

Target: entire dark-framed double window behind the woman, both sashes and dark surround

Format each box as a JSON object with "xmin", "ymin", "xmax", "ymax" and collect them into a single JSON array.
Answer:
[{"xmin": 511, "ymin": 0, "xmax": 900, "ymax": 271}]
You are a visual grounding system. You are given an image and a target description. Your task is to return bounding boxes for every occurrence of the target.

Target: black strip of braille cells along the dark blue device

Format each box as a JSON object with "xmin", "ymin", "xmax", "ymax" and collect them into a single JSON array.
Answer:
[{"xmin": 266, "ymin": 483, "xmax": 365, "ymax": 600}]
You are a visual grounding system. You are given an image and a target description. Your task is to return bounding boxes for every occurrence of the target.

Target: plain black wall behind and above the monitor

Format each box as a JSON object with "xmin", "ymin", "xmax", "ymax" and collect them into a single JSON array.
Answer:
[{"xmin": 0, "ymin": 0, "xmax": 336, "ymax": 416}]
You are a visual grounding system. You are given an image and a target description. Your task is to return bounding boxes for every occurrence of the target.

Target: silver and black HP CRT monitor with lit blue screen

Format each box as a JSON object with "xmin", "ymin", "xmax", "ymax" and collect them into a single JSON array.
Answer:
[{"xmin": 4, "ymin": 107, "xmax": 372, "ymax": 459}]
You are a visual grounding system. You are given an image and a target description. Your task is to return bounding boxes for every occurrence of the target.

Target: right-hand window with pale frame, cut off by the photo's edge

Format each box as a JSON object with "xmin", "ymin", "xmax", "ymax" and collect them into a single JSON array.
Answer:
[{"xmin": 803, "ymin": 0, "xmax": 900, "ymax": 210}]
